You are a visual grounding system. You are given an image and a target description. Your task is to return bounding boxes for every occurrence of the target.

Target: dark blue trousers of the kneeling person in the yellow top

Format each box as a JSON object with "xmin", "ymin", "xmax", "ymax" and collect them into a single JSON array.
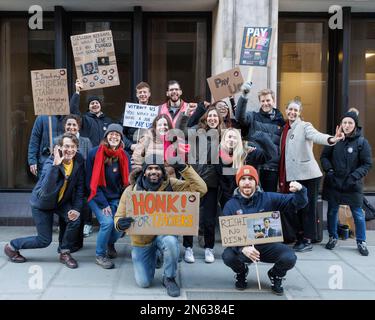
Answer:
[{"xmin": 10, "ymin": 208, "xmax": 81, "ymax": 251}]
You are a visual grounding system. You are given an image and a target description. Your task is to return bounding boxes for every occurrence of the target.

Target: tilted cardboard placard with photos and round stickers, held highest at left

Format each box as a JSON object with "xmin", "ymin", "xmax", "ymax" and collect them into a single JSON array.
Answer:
[{"xmin": 70, "ymin": 30, "xmax": 120, "ymax": 91}]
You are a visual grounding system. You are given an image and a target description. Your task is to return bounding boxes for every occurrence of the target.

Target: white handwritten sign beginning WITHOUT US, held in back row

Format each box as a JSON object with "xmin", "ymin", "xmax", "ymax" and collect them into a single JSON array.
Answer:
[{"xmin": 123, "ymin": 102, "xmax": 159, "ymax": 129}]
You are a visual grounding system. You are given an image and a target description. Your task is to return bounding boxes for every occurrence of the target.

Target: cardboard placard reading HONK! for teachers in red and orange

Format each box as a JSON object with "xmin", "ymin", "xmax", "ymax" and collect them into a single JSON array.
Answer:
[{"xmin": 125, "ymin": 191, "xmax": 199, "ymax": 236}]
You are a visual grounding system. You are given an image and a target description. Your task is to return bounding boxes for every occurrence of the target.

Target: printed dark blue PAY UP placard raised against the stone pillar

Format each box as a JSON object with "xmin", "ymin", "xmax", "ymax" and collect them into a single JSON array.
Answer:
[{"xmin": 239, "ymin": 27, "xmax": 272, "ymax": 67}]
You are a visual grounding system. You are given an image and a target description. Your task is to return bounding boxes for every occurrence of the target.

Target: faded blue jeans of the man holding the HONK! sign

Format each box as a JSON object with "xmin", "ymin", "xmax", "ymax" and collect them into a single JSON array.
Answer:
[{"xmin": 132, "ymin": 235, "xmax": 180, "ymax": 288}]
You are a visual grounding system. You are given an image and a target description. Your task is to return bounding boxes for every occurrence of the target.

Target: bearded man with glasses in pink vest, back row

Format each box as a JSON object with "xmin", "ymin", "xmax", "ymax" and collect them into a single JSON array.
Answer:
[{"xmin": 159, "ymin": 80, "xmax": 197, "ymax": 128}]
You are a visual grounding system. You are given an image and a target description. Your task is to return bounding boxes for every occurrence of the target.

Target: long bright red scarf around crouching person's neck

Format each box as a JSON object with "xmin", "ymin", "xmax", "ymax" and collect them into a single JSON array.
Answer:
[{"xmin": 87, "ymin": 145, "xmax": 129, "ymax": 201}]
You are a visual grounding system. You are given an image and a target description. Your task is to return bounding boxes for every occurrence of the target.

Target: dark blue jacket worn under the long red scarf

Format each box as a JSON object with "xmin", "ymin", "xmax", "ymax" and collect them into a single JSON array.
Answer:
[{"xmin": 86, "ymin": 147, "xmax": 131, "ymax": 209}]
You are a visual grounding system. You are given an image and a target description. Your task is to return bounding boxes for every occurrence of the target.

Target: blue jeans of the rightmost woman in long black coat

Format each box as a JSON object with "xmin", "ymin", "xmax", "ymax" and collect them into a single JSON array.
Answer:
[{"xmin": 327, "ymin": 203, "xmax": 366, "ymax": 241}]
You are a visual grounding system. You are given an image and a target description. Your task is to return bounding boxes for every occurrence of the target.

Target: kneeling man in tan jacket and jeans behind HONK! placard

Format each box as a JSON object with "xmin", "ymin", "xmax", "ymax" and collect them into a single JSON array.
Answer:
[{"xmin": 114, "ymin": 154, "xmax": 207, "ymax": 297}]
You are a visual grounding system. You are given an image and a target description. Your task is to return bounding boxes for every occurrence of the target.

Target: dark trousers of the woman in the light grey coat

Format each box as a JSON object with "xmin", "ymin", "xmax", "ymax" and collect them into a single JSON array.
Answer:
[{"xmin": 296, "ymin": 178, "xmax": 320, "ymax": 240}]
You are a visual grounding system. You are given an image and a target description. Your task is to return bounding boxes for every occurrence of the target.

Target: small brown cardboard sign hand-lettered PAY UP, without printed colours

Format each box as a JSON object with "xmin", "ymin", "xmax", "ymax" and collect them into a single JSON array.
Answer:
[{"xmin": 207, "ymin": 67, "xmax": 244, "ymax": 101}]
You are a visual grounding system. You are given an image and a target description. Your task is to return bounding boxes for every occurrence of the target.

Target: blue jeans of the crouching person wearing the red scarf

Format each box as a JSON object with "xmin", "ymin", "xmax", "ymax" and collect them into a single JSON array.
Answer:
[{"xmin": 89, "ymin": 199, "xmax": 121, "ymax": 257}]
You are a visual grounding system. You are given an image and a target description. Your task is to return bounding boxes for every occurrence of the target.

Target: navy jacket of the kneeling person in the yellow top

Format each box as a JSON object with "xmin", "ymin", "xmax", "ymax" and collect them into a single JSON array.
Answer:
[{"xmin": 30, "ymin": 153, "xmax": 85, "ymax": 212}]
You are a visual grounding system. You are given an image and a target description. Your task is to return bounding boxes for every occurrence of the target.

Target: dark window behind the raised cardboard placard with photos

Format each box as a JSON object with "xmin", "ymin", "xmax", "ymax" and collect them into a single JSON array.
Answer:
[{"xmin": 72, "ymin": 18, "xmax": 132, "ymax": 122}]
